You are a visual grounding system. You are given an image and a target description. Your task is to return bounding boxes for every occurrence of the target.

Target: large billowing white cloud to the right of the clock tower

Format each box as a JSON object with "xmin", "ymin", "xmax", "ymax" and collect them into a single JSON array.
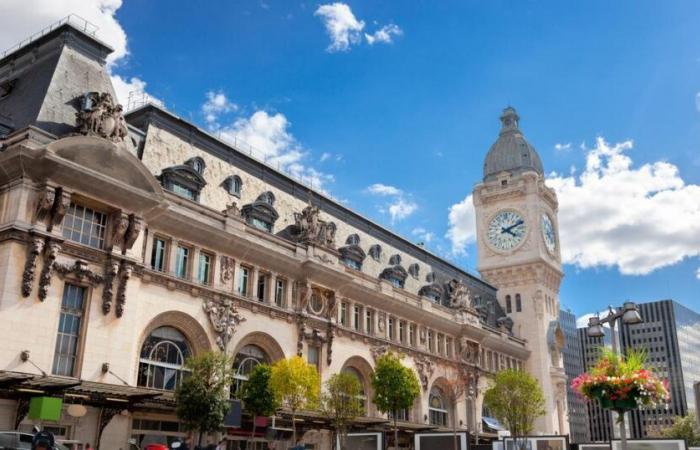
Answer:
[{"xmin": 547, "ymin": 137, "xmax": 700, "ymax": 275}]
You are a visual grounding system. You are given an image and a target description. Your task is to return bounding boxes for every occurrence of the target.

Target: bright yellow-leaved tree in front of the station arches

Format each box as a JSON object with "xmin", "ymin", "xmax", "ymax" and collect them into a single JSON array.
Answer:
[{"xmin": 270, "ymin": 356, "xmax": 321, "ymax": 445}]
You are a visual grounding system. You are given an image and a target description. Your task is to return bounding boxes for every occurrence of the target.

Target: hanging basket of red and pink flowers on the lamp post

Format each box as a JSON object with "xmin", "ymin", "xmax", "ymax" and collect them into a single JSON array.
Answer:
[{"xmin": 571, "ymin": 351, "xmax": 670, "ymax": 413}]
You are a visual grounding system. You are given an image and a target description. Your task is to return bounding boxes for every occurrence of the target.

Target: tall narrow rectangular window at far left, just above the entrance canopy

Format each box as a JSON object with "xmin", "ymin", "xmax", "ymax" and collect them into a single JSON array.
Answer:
[{"xmin": 52, "ymin": 283, "xmax": 85, "ymax": 377}]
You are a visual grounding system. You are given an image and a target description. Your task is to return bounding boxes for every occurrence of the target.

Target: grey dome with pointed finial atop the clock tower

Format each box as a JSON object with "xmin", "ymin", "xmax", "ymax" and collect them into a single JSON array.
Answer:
[{"xmin": 484, "ymin": 106, "xmax": 544, "ymax": 181}]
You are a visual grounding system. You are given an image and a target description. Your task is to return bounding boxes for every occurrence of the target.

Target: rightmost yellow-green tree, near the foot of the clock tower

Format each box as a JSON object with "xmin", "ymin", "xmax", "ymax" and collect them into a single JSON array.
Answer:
[{"xmin": 484, "ymin": 369, "xmax": 545, "ymax": 446}]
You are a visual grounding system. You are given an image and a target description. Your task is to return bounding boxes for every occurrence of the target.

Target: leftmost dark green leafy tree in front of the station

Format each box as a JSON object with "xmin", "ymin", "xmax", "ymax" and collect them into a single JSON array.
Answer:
[{"xmin": 175, "ymin": 352, "xmax": 233, "ymax": 444}]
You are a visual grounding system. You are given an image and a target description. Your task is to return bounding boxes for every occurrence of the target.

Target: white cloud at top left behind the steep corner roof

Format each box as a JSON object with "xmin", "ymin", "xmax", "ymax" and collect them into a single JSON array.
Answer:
[{"xmin": 0, "ymin": 0, "xmax": 157, "ymax": 106}]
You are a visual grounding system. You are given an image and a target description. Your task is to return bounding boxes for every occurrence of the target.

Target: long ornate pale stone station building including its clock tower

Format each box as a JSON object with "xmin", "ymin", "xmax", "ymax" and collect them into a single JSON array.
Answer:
[{"xmin": 0, "ymin": 24, "xmax": 568, "ymax": 449}]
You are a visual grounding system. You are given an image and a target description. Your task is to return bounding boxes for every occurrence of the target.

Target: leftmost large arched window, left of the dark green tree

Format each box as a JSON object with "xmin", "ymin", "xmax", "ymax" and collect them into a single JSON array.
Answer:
[{"xmin": 138, "ymin": 327, "xmax": 191, "ymax": 391}]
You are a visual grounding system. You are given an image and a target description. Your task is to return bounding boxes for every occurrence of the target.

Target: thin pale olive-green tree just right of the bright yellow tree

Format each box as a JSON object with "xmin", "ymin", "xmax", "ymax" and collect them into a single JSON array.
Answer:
[{"xmin": 321, "ymin": 372, "xmax": 364, "ymax": 450}]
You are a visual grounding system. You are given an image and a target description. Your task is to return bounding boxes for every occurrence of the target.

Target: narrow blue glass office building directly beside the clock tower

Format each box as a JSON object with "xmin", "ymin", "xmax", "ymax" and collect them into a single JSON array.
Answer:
[{"xmin": 559, "ymin": 309, "xmax": 591, "ymax": 443}]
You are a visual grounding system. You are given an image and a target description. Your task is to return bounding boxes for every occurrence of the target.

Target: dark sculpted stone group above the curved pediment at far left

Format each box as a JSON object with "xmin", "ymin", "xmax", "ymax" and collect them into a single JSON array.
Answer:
[{"xmin": 75, "ymin": 92, "xmax": 129, "ymax": 142}]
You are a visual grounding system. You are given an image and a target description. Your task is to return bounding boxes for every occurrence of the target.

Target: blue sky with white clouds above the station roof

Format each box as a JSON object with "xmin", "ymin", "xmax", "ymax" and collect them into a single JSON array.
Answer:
[{"xmin": 0, "ymin": 0, "xmax": 700, "ymax": 314}]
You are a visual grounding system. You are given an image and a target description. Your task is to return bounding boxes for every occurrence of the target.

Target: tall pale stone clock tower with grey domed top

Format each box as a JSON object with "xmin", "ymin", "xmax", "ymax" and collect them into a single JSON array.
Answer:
[{"xmin": 473, "ymin": 107, "xmax": 569, "ymax": 434}]
